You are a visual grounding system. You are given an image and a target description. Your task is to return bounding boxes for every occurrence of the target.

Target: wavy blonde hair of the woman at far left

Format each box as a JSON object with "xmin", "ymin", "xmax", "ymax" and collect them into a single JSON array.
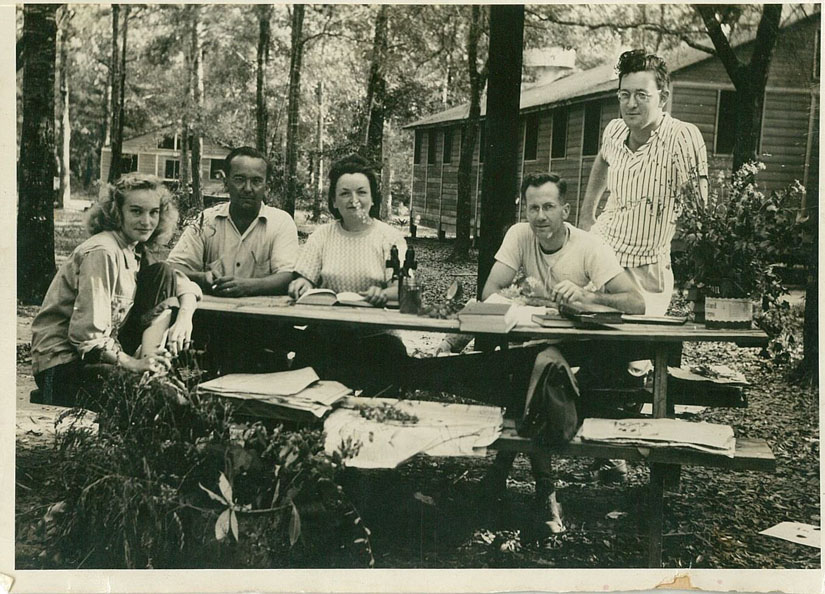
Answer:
[{"xmin": 86, "ymin": 173, "xmax": 178, "ymax": 249}]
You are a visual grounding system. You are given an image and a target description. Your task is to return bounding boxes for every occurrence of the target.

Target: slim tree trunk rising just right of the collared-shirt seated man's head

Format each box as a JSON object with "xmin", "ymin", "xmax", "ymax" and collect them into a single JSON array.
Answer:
[{"xmin": 282, "ymin": 4, "xmax": 304, "ymax": 217}]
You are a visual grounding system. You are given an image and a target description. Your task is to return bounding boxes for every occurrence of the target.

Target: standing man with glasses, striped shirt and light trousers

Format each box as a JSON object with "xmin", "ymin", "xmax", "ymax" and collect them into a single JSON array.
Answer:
[{"xmin": 579, "ymin": 50, "xmax": 708, "ymax": 315}]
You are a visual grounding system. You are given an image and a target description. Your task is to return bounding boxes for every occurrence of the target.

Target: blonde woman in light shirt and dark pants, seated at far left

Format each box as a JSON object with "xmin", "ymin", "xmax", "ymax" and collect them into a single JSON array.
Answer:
[{"xmin": 32, "ymin": 173, "xmax": 201, "ymax": 406}]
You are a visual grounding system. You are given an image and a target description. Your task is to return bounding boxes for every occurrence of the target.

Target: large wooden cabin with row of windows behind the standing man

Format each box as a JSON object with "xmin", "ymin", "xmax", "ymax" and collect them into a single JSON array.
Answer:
[{"xmin": 405, "ymin": 8, "xmax": 821, "ymax": 235}]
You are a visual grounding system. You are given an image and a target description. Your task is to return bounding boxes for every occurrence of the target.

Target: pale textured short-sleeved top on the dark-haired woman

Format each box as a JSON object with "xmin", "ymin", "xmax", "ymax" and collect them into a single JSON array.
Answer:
[{"xmin": 295, "ymin": 220, "xmax": 407, "ymax": 293}]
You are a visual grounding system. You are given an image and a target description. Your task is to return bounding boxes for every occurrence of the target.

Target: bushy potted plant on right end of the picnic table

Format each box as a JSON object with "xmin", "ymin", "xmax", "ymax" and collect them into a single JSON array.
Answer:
[{"xmin": 675, "ymin": 163, "xmax": 804, "ymax": 328}]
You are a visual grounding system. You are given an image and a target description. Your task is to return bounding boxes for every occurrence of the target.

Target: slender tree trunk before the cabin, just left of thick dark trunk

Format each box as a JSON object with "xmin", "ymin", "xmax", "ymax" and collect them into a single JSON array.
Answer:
[{"xmin": 452, "ymin": 4, "xmax": 487, "ymax": 260}]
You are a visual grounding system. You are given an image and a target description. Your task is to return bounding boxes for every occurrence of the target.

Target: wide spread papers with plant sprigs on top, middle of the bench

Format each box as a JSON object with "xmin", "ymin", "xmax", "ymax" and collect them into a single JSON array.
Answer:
[{"xmin": 324, "ymin": 397, "xmax": 504, "ymax": 468}]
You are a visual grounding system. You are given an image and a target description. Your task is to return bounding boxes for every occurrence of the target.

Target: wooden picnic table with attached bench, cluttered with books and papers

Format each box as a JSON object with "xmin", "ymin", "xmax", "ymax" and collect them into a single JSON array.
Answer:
[{"xmin": 199, "ymin": 296, "xmax": 775, "ymax": 567}]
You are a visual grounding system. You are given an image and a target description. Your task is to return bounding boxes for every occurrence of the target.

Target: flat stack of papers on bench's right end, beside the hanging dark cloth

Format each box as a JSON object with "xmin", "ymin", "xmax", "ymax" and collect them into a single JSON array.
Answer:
[{"xmin": 578, "ymin": 419, "xmax": 736, "ymax": 458}]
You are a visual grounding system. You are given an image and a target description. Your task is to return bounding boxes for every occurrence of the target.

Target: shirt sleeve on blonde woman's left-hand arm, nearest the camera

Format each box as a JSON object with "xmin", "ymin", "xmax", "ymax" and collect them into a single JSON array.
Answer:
[{"xmin": 69, "ymin": 250, "xmax": 122, "ymax": 357}]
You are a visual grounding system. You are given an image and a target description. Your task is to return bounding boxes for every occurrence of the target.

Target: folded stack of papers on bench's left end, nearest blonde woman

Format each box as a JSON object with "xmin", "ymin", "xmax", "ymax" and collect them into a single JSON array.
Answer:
[{"xmin": 198, "ymin": 367, "xmax": 351, "ymax": 421}]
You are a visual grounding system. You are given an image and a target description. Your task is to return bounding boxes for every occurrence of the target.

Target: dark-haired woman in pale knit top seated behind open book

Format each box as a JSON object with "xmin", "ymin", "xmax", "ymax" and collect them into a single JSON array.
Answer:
[{"xmin": 289, "ymin": 155, "xmax": 407, "ymax": 387}]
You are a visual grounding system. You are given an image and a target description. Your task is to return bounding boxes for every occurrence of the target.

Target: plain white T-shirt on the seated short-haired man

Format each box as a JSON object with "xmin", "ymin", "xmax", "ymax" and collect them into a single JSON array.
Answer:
[{"xmin": 496, "ymin": 223, "xmax": 623, "ymax": 296}]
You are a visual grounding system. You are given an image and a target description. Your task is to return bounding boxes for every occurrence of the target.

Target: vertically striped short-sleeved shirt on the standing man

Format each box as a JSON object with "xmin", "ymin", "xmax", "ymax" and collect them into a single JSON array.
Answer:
[{"xmin": 591, "ymin": 113, "xmax": 708, "ymax": 267}]
